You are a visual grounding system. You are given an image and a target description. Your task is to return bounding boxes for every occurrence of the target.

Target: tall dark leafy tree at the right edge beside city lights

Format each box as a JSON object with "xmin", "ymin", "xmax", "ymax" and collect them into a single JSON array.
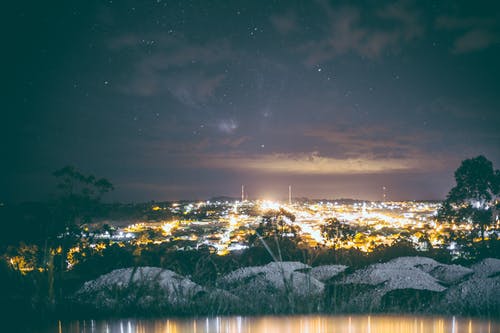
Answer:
[{"xmin": 438, "ymin": 156, "xmax": 500, "ymax": 241}]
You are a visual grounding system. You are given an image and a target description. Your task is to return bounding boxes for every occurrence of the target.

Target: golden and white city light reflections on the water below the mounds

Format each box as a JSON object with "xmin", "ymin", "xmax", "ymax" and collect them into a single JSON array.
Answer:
[{"xmin": 47, "ymin": 316, "xmax": 500, "ymax": 333}]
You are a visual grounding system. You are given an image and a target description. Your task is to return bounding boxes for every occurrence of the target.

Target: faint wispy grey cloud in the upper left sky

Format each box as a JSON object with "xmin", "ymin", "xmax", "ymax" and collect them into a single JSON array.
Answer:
[{"xmin": 108, "ymin": 34, "xmax": 233, "ymax": 108}]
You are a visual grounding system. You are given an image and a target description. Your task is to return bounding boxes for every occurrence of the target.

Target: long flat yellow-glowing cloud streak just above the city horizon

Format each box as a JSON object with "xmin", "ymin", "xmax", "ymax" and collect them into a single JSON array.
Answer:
[{"xmin": 201, "ymin": 152, "xmax": 441, "ymax": 175}]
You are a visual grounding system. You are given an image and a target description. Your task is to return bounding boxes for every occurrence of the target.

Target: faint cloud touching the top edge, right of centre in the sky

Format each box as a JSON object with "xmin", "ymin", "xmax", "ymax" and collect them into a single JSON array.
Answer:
[{"xmin": 301, "ymin": 1, "xmax": 424, "ymax": 66}]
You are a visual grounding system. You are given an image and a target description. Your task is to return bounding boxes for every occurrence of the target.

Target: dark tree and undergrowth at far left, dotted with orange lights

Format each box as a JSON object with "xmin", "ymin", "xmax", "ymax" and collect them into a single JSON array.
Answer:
[{"xmin": 0, "ymin": 166, "xmax": 113, "ymax": 326}]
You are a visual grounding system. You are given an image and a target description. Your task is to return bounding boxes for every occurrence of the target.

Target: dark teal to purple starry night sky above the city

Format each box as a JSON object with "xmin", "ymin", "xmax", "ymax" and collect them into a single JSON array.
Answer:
[{"xmin": 0, "ymin": 0, "xmax": 500, "ymax": 202}]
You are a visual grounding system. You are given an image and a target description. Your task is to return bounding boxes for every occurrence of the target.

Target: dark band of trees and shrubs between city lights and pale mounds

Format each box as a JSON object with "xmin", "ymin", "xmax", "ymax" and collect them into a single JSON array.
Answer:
[{"xmin": 0, "ymin": 156, "xmax": 500, "ymax": 330}]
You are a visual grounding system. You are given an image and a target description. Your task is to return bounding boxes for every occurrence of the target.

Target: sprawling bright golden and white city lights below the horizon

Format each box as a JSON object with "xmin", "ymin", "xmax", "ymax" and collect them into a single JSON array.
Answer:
[{"xmin": 8, "ymin": 200, "xmax": 500, "ymax": 271}]
